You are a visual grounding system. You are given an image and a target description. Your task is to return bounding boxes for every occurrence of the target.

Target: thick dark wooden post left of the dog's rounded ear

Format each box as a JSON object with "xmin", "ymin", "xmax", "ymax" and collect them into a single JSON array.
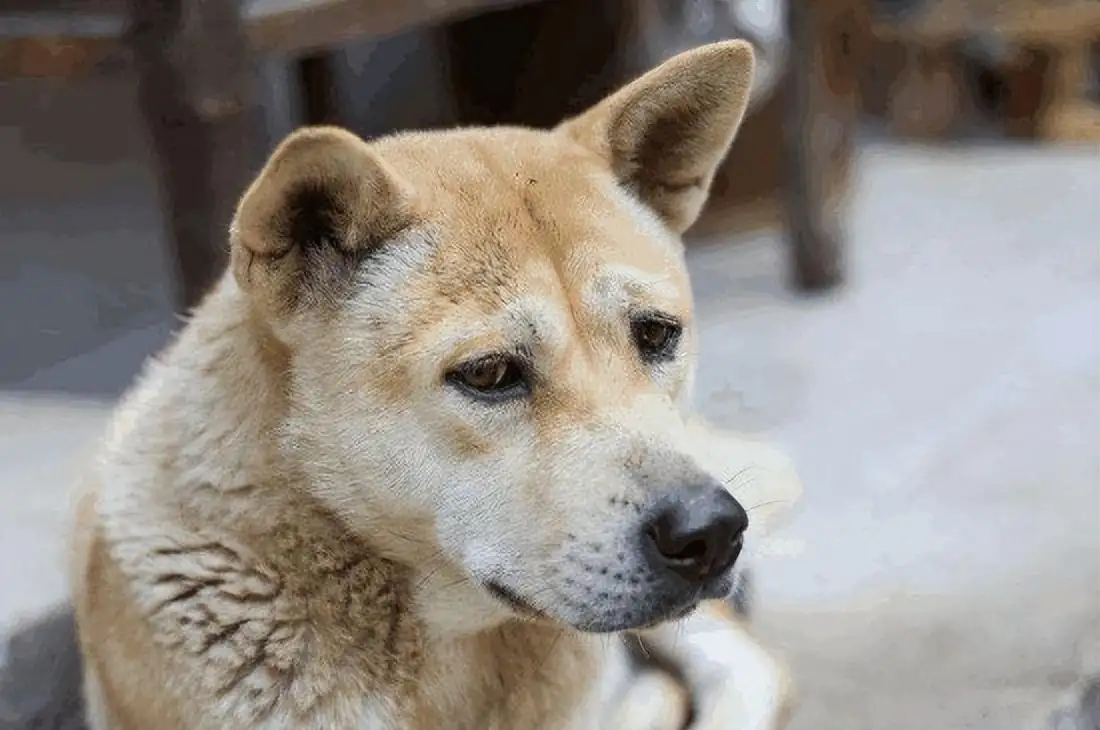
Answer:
[{"xmin": 127, "ymin": 0, "xmax": 266, "ymax": 310}]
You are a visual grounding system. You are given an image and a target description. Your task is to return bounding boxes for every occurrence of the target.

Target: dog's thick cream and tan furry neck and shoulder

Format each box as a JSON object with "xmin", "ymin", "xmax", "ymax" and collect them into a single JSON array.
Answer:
[{"xmin": 72, "ymin": 322, "xmax": 420, "ymax": 727}]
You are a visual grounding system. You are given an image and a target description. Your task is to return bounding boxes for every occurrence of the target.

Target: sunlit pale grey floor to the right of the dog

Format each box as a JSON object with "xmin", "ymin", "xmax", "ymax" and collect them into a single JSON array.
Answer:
[{"xmin": 692, "ymin": 147, "xmax": 1100, "ymax": 730}]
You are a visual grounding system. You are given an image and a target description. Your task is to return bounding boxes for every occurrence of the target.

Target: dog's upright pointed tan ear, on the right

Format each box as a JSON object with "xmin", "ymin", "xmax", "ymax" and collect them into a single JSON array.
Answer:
[{"xmin": 559, "ymin": 41, "xmax": 752, "ymax": 233}]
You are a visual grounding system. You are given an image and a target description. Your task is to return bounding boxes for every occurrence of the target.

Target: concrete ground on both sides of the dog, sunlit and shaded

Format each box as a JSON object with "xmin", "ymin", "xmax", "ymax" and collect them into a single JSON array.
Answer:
[{"xmin": 0, "ymin": 75, "xmax": 1100, "ymax": 730}]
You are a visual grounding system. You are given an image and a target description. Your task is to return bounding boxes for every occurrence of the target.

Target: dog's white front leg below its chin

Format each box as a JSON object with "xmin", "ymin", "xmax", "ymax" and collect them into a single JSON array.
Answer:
[{"xmin": 641, "ymin": 601, "xmax": 794, "ymax": 730}]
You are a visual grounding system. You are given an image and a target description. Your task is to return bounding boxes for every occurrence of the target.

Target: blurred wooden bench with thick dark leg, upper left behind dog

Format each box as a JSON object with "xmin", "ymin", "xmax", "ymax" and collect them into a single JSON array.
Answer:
[{"xmin": 0, "ymin": 0, "xmax": 539, "ymax": 309}]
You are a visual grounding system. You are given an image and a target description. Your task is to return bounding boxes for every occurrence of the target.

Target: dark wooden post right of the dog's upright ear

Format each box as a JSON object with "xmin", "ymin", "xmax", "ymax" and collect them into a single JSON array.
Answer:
[{"xmin": 783, "ymin": 0, "xmax": 857, "ymax": 291}]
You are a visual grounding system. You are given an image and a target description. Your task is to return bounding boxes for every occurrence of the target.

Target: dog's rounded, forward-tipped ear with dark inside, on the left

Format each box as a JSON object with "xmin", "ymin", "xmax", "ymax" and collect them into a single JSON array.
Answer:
[{"xmin": 230, "ymin": 126, "xmax": 416, "ymax": 313}]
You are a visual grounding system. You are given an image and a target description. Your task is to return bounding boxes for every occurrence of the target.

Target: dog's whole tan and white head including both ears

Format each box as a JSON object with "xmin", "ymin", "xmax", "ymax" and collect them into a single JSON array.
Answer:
[{"xmin": 232, "ymin": 42, "xmax": 752, "ymax": 631}]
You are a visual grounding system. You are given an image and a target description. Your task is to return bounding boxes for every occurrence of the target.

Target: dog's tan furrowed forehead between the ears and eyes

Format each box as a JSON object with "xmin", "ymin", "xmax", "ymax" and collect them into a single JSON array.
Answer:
[{"xmin": 385, "ymin": 129, "xmax": 690, "ymax": 309}]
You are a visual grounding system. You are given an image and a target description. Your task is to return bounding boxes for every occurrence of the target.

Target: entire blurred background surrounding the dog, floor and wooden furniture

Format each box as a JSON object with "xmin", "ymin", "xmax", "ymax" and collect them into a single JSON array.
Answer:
[{"xmin": 0, "ymin": 0, "xmax": 1100, "ymax": 730}]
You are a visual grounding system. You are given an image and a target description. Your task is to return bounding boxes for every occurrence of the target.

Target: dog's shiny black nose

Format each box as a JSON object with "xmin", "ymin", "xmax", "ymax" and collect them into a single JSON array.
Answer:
[{"xmin": 646, "ymin": 486, "xmax": 749, "ymax": 584}]
